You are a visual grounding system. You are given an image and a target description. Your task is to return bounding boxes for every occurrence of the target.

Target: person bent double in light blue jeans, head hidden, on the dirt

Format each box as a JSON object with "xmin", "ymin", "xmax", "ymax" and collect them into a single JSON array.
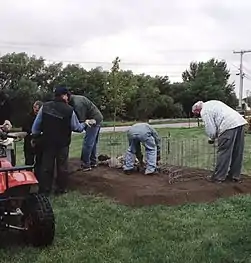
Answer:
[{"xmin": 123, "ymin": 123, "xmax": 160, "ymax": 175}]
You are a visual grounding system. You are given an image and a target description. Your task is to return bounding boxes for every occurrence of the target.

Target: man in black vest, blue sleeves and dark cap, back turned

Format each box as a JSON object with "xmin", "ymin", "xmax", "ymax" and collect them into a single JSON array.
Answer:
[{"xmin": 32, "ymin": 87, "xmax": 86, "ymax": 194}]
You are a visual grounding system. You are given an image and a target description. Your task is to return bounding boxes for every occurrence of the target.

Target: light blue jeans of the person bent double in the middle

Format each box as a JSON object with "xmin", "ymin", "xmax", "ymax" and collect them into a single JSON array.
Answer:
[{"xmin": 124, "ymin": 136, "xmax": 157, "ymax": 174}]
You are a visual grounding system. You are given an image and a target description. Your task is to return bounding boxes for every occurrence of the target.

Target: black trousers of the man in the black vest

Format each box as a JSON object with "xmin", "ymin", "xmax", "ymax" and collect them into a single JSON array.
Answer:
[{"xmin": 39, "ymin": 146, "xmax": 69, "ymax": 194}]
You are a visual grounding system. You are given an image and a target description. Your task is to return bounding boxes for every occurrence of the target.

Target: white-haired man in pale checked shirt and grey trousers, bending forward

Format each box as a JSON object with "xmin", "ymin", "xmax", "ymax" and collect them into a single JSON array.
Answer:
[{"xmin": 192, "ymin": 100, "xmax": 247, "ymax": 182}]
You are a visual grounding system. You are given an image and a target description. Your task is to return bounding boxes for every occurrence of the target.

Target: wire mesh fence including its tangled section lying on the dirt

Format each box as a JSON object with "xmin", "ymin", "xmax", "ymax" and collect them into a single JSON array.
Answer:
[{"xmin": 93, "ymin": 134, "xmax": 219, "ymax": 183}]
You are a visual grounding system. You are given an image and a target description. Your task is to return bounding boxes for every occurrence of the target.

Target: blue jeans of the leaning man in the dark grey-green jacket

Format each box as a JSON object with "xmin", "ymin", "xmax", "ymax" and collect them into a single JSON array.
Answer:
[{"xmin": 81, "ymin": 125, "xmax": 100, "ymax": 166}]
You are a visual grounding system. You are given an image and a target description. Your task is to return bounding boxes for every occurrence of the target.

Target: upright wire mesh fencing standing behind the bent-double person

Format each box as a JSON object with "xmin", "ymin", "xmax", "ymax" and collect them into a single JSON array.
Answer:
[{"xmin": 95, "ymin": 135, "xmax": 216, "ymax": 170}]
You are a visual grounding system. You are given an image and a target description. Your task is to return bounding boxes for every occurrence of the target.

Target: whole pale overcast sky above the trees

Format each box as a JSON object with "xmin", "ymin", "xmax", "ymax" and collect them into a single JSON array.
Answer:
[{"xmin": 0, "ymin": 0, "xmax": 251, "ymax": 95}]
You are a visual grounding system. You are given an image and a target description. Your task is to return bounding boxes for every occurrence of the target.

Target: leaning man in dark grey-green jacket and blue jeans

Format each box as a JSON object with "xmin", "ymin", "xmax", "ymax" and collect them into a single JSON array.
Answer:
[{"xmin": 69, "ymin": 95, "xmax": 103, "ymax": 171}]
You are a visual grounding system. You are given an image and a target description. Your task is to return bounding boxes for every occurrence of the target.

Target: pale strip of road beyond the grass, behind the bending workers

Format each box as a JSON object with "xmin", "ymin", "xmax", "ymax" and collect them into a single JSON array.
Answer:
[{"xmin": 101, "ymin": 122, "xmax": 198, "ymax": 132}]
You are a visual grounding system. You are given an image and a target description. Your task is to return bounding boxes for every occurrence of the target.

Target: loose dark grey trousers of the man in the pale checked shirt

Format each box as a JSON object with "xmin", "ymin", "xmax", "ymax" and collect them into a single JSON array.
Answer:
[{"xmin": 214, "ymin": 126, "xmax": 245, "ymax": 181}]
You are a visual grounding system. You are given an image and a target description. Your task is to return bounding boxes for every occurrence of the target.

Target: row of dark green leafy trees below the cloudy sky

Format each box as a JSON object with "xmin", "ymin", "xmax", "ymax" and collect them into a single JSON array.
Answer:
[{"xmin": 0, "ymin": 53, "xmax": 237, "ymax": 126}]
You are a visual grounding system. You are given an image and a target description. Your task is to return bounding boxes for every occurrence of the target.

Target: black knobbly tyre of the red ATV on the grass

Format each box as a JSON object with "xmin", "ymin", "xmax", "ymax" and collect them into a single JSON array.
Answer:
[{"xmin": 22, "ymin": 194, "xmax": 55, "ymax": 247}]
